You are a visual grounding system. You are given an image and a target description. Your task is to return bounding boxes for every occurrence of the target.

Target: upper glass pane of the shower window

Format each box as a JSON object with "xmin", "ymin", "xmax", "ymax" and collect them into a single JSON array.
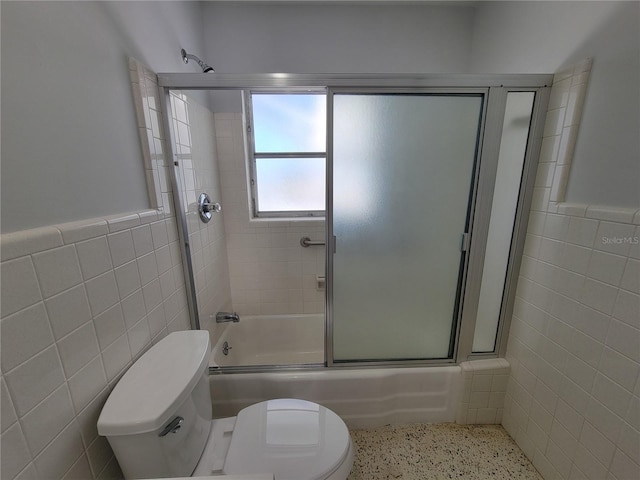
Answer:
[{"xmin": 251, "ymin": 94, "xmax": 327, "ymax": 153}]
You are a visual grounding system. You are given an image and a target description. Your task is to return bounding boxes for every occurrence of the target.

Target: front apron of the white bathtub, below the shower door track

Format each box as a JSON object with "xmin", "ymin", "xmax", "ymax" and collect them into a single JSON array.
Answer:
[{"xmin": 209, "ymin": 365, "xmax": 462, "ymax": 428}]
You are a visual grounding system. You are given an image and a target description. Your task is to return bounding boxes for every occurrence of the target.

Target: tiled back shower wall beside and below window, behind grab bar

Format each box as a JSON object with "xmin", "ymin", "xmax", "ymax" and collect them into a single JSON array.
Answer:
[{"xmin": 215, "ymin": 113, "xmax": 325, "ymax": 315}]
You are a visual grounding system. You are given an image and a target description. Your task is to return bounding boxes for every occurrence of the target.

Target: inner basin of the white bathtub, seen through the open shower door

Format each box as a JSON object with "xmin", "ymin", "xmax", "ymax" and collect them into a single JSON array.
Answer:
[{"xmin": 209, "ymin": 314, "xmax": 324, "ymax": 367}]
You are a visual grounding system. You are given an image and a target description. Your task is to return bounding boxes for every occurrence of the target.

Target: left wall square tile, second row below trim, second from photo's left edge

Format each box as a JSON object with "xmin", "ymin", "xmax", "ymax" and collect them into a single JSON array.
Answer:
[{"xmin": 45, "ymin": 284, "xmax": 91, "ymax": 338}]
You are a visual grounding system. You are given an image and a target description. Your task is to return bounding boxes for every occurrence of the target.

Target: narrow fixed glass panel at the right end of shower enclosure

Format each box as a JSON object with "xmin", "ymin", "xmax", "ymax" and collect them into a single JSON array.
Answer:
[{"xmin": 473, "ymin": 92, "xmax": 535, "ymax": 353}]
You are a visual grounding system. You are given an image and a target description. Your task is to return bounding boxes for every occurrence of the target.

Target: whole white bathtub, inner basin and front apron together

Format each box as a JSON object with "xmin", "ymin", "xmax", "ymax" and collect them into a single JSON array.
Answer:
[{"xmin": 209, "ymin": 315, "xmax": 462, "ymax": 428}]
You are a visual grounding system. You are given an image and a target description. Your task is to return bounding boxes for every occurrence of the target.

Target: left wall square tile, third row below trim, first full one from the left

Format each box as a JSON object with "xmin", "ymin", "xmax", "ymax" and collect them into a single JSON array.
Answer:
[{"xmin": 5, "ymin": 346, "xmax": 64, "ymax": 416}]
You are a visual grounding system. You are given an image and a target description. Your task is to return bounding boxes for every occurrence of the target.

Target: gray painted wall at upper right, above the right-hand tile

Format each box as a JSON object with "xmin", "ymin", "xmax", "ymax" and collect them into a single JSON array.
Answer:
[{"xmin": 471, "ymin": 2, "xmax": 640, "ymax": 207}]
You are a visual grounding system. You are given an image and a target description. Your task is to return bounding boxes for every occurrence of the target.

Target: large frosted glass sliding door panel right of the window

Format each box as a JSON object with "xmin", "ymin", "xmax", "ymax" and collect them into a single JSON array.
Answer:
[{"xmin": 333, "ymin": 94, "xmax": 483, "ymax": 361}]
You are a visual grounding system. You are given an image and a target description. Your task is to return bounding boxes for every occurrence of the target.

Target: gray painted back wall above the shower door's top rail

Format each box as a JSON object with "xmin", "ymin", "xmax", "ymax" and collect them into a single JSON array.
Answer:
[{"xmin": 203, "ymin": 2, "xmax": 474, "ymax": 73}]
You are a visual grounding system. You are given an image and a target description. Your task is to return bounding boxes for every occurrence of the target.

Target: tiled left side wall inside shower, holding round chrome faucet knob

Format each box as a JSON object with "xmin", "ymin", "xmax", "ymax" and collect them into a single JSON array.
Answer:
[{"xmin": 171, "ymin": 92, "xmax": 233, "ymax": 334}]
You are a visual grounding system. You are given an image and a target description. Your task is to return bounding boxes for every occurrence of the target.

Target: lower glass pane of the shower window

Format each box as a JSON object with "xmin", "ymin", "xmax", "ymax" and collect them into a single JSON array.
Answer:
[{"xmin": 256, "ymin": 158, "xmax": 325, "ymax": 212}]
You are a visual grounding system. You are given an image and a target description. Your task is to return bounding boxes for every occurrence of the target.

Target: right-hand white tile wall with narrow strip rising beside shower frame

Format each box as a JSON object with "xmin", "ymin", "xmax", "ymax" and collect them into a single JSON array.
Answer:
[{"xmin": 502, "ymin": 60, "xmax": 640, "ymax": 480}]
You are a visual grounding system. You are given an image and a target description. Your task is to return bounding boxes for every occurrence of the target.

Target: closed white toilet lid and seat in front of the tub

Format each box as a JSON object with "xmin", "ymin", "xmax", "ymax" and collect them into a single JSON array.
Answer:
[{"xmin": 223, "ymin": 399, "xmax": 353, "ymax": 480}]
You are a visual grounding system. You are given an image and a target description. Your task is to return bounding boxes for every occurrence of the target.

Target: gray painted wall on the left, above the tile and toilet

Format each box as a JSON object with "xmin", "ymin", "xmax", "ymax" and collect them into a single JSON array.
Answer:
[{"xmin": 1, "ymin": 1, "xmax": 203, "ymax": 233}]
